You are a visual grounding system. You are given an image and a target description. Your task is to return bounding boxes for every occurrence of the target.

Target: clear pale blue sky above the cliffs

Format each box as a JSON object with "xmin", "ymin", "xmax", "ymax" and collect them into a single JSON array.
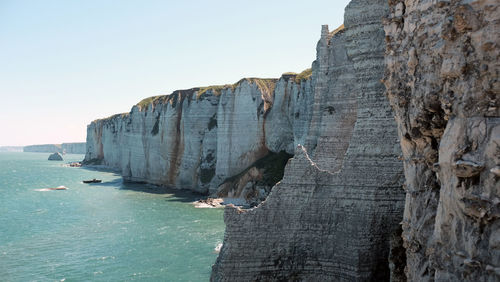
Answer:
[{"xmin": 0, "ymin": 0, "xmax": 349, "ymax": 146}]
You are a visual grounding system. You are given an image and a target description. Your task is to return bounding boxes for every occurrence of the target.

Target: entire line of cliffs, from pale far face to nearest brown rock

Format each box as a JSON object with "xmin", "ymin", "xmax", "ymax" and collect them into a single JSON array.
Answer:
[{"xmin": 84, "ymin": 0, "xmax": 500, "ymax": 281}]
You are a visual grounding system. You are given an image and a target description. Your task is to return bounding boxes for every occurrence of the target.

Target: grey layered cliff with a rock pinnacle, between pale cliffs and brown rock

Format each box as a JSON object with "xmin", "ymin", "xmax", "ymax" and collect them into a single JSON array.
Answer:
[{"xmin": 212, "ymin": 0, "xmax": 404, "ymax": 281}]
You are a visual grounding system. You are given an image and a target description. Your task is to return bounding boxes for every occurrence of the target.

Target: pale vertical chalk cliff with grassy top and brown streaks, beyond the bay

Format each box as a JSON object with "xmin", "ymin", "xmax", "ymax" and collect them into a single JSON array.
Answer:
[{"xmin": 85, "ymin": 75, "xmax": 312, "ymax": 199}]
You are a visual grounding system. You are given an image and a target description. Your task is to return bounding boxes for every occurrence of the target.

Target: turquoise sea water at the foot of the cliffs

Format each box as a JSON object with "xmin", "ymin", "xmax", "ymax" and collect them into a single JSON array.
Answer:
[{"xmin": 0, "ymin": 153, "xmax": 224, "ymax": 281}]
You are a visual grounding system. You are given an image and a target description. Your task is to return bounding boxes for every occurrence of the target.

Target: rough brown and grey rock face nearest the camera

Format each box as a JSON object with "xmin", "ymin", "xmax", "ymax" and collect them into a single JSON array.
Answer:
[{"xmin": 385, "ymin": 0, "xmax": 500, "ymax": 281}]
